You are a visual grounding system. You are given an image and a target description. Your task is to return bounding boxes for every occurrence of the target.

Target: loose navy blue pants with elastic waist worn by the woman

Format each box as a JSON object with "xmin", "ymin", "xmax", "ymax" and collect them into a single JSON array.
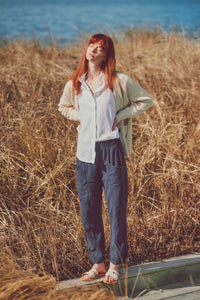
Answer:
[{"xmin": 76, "ymin": 139, "xmax": 128, "ymax": 264}]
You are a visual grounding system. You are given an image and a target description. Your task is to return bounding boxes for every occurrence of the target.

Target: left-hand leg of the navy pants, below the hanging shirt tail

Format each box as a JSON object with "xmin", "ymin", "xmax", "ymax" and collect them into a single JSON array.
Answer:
[{"xmin": 76, "ymin": 159, "xmax": 105, "ymax": 263}]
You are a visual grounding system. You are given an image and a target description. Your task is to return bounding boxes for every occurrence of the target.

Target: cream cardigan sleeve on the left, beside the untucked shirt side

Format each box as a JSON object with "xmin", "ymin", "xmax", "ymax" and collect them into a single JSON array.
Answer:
[{"xmin": 58, "ymin": 81, "xmax": 80, "ymax": 121}]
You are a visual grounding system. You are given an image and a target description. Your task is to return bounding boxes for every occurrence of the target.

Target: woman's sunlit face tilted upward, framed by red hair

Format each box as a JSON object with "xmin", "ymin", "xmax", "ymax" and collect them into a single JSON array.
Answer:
[{"xmin": 86, "ymin": 43, "xmax": 106, "ymax": 66}]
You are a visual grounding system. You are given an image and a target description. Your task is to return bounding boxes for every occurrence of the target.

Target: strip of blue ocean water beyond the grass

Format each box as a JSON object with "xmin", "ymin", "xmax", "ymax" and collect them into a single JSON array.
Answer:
[{"xmin": 0, "ymin": 0, "xmax": 200, "ymax": 43}]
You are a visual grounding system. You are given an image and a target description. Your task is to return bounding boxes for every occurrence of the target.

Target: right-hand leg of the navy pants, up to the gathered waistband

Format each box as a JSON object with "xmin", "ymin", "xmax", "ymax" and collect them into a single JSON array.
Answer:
[{"xmin": 103, "ymin": 140, "xmax": 128, "ymax": 264}]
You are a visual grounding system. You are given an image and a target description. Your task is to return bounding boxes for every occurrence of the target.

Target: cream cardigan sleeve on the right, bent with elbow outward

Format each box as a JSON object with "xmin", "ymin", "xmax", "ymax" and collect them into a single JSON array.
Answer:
[{"xmin": 116, "ymin": 77, "xmax": 153, "ymax": 122}]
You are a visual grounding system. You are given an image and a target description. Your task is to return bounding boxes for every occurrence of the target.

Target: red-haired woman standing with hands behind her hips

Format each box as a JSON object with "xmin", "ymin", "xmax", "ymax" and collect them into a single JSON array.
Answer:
[{"xmin": 59, "ymin": 34, "xmax": 152, "ymax": 283}]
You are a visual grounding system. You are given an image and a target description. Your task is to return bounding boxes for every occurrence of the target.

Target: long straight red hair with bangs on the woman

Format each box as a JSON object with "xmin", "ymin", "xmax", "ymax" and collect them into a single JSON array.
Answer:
[{"xmin": 69, "ymin": 33, "xmax": 117, "ymax": 94}]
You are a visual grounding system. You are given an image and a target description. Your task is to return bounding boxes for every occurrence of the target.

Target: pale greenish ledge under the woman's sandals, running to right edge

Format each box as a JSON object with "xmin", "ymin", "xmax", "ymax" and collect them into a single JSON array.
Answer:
[{"xmin": 57, "ymin": 253, "xmax": 200, "ymax": 296}]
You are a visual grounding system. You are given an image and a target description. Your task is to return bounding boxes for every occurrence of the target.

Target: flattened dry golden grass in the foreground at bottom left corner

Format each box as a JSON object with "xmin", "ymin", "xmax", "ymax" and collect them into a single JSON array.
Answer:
[{"xmin": 0, "ymin": 253, "xmax": 117, "ymax": 300}]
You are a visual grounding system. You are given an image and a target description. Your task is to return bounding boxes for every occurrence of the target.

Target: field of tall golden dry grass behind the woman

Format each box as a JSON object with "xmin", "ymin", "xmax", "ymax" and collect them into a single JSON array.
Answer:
[{"xmin": 0, "ymin": 30, "xmax": 200, "ymax": 292}]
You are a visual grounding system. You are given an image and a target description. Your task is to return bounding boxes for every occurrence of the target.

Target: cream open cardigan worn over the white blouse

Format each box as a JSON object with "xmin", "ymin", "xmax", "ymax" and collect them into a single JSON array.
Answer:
[{"xmin": 58, "ymin": 72, "xmax": 153, "ymax": 155}]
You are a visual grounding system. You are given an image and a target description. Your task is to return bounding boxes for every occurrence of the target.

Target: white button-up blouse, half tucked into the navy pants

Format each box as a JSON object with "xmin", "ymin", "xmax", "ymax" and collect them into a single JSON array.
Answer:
[{"xmin": 77, "ymin": 72, "xmax": 119, "ymax": 163}]
